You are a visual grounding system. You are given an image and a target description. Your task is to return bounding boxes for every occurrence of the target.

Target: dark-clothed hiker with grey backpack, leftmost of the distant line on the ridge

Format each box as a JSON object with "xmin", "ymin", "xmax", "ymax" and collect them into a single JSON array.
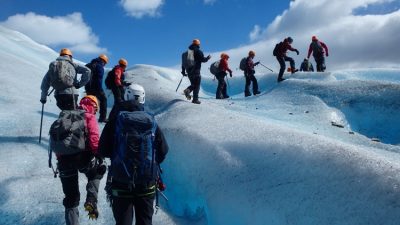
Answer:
[{"xmin": 182, "ymin": 39, "xmax": 211, "ymax": 104}]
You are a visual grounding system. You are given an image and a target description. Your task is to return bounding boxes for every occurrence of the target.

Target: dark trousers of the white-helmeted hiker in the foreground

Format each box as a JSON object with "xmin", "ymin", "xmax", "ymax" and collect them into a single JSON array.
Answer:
[{"xmin": 112, "ymin": 195, "xmax": 154, "ymax": 225}]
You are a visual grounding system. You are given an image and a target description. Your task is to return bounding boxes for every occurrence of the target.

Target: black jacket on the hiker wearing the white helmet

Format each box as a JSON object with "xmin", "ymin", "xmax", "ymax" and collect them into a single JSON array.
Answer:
[{"xmin": 99, "ymin": 101, "xmax": 168, "ymax": 164}]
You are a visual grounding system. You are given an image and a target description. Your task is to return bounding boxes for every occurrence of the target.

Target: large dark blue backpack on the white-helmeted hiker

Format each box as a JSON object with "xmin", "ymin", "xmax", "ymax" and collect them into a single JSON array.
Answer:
[{"xmin": 109, "ymin": 111, "xmax": 158, "ymax": 188}]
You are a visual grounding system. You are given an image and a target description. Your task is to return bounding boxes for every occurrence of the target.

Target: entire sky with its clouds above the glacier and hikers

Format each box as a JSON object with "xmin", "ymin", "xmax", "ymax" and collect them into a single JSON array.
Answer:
[{"xmin": 0, "ymin": 0, "xmax": 400, "ymax": 72}]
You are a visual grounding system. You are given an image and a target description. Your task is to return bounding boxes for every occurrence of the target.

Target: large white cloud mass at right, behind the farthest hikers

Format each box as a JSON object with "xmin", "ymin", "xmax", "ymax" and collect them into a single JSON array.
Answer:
[{"xmin": 222, "ymin": 0, "xmax": 400, "ymax": 70}]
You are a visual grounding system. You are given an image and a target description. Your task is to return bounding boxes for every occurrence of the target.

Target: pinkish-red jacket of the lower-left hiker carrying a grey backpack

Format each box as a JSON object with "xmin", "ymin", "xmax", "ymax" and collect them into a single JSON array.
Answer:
[{"xmin": 79, "ymin": 99, "xmax": 100, "ymax": 154}]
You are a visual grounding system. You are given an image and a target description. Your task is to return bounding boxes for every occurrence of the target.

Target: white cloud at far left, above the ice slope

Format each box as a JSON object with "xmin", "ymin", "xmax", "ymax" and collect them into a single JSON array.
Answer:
[{"xmin": 0, "ymin": 12, "xmax": 107, "ymax": 54}]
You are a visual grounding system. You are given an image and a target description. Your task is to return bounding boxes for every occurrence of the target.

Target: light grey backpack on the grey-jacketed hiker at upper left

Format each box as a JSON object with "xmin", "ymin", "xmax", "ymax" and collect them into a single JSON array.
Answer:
[{"xmin": 49, "ymin": 60, "xmax": 76, "ymax": 91}]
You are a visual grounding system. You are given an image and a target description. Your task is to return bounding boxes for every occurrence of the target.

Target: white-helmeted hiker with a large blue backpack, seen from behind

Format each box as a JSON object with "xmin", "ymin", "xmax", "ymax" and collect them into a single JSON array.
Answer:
[{"xmin": 99, "ymin": 84, "xmax": 168, "ymax": 225}]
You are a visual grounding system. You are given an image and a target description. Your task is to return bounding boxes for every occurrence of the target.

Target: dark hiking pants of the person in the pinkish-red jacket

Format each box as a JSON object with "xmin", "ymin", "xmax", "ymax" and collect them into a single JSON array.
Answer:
[{"xmin": 57, "ymin": 152, "xmax": 103, "ymax": 225}]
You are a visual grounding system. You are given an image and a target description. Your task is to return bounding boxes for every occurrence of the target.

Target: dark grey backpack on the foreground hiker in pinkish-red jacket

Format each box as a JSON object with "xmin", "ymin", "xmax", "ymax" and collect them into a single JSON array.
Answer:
[{"xmin": 49, "ymin": 109, "xmax": 87, "ymax": 155}]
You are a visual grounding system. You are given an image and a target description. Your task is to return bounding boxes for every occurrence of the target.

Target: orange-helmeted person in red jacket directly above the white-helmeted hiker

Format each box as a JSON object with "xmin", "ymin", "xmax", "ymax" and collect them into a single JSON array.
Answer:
[{"xmin": 111, "ymin": 58, "xmax": 128, "ymax": 105}]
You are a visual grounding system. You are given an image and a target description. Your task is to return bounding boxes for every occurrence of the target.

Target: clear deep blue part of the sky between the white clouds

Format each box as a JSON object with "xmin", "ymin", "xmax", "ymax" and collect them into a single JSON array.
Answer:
[{"xmin": 0, "ymin": 0, "xmax": 289, "ymax": 66}]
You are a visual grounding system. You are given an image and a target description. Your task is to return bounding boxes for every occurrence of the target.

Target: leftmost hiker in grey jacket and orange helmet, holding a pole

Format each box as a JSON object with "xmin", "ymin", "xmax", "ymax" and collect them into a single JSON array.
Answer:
[{"xmin": 40, "ymin": 48, "xmax": 91, "ymax": 110}]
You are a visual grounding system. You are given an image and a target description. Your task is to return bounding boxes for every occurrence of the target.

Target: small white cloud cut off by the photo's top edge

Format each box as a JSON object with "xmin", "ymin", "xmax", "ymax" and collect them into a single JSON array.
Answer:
[{"xmin": 120, "ymin": 0, "xmax": 164, "ymax": 18}]
